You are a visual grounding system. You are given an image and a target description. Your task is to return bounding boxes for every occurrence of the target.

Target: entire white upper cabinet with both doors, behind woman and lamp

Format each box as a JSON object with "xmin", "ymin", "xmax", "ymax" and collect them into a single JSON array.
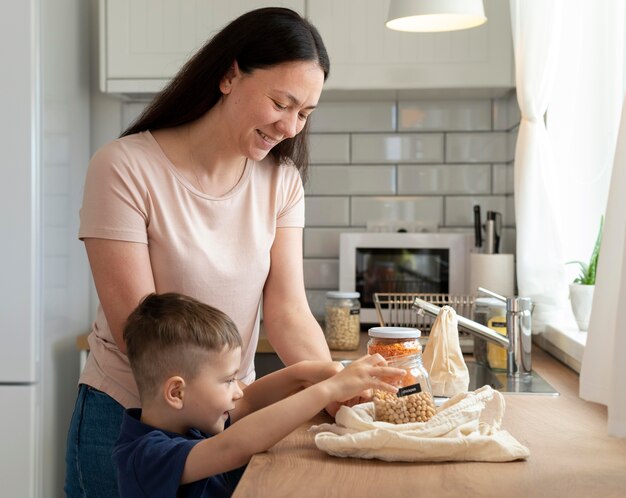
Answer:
[{"xmin": 99, "ymin": 0, "xmax": 515, "ymax": 93}]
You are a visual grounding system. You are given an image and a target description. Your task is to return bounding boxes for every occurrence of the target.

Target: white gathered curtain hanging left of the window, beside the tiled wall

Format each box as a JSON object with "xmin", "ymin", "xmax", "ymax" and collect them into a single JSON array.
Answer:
[{"xmin": 510, "ymin": 0, "xmax": 569, "ymax": 333}]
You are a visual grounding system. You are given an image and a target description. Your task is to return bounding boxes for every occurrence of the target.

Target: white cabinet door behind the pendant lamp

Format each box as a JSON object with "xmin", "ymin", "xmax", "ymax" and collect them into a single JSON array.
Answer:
[{"xmin": 307, "ymin": 0, "xmax": 515, "ymax": 89}]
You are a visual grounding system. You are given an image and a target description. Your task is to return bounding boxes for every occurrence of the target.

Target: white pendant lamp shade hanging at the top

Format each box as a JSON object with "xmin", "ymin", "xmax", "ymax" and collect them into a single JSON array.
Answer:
[{"xmin": 385, "ymin": 0, "xmax": 487, "ymax": 32}]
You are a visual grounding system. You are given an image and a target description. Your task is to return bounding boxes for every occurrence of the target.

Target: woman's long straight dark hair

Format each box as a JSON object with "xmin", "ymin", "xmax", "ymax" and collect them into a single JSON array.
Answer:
[{"xmin": 120, "ymin": 7, "xmax": 330, "ymax": 178}]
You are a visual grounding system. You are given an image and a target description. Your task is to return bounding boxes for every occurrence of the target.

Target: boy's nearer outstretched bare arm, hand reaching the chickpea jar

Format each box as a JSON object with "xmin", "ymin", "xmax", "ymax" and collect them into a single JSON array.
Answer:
[{"xmin": 181, "ymin": 354, "xmax": 405, "ymax": 484}]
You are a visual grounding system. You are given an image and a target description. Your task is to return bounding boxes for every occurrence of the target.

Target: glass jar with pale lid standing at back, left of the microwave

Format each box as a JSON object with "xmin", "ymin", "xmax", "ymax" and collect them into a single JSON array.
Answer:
[{"xmin": 324, "ymin": 291, "xmax": 361, "ymax": 351}]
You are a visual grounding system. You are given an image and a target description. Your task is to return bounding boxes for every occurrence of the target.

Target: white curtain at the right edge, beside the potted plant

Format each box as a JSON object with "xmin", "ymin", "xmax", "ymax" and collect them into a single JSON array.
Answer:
[{"xmin": 580, "ymin": 95, "xmax": 626, "ymax": 437}]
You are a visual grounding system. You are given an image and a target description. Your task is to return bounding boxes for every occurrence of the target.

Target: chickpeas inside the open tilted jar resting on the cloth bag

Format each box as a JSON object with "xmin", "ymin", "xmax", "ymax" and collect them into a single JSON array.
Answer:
[{"xmin": 373, "ymin": 390, "xmax": 436, "ymax": 424}]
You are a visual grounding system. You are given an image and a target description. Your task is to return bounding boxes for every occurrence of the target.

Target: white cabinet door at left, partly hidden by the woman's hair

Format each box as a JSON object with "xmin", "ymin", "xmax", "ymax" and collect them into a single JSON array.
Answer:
[{"xmin": 99, "ymin": 0, "xmax": 304, "ymax": 92}]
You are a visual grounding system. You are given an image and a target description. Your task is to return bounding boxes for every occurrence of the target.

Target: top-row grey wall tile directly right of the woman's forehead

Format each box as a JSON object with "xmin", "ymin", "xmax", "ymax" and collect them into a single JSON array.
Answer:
[{"xmin": 309, "ymin": 102, "xmax": 396, "ymax": 133}]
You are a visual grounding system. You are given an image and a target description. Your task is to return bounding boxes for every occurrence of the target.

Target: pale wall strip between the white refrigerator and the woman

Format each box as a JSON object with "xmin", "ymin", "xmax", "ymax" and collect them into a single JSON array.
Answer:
[{"xmin": 40, "ymin": 0, "xmax": 91, "ymax": 497}]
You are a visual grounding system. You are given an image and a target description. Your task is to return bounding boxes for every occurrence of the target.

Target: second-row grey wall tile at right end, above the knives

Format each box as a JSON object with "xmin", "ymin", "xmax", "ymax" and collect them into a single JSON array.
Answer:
[{"xmin": 446, "ymin": 132, "xmax": 512, "ymax": 163}]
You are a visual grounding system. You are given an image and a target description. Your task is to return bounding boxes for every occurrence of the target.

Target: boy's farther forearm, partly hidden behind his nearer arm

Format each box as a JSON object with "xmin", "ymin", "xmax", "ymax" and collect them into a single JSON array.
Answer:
[{"xmin": 230, "ymin": 361, "xmax": 343, "ymax": 423}]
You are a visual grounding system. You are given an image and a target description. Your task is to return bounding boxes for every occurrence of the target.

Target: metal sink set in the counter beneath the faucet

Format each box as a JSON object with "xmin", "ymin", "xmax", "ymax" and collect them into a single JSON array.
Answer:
[{"xmin": 466, "ymin": 361, "xmax": 559, "ymax": 396}]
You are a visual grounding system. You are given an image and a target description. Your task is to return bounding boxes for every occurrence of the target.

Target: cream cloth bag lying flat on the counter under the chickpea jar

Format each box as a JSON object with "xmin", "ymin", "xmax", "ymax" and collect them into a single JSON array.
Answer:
[{"xmin": 310, "ymin": 386, "xmax": 530, "ymax": 462}]
